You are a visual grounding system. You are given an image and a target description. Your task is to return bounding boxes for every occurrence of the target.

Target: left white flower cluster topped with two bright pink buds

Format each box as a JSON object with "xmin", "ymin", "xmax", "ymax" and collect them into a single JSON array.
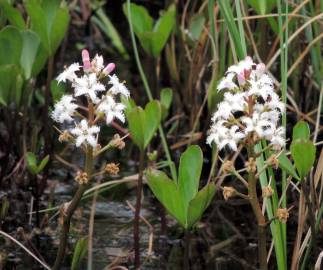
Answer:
[{"xmin": 51, "ymin": 50, "xmax": 130, "ymax": 147}]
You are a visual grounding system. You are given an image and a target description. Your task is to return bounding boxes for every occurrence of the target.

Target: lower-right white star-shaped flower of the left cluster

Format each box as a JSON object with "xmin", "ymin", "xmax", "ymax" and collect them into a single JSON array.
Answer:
[{"xmin": 97, "ymin": 95, "xmax": 126, "ymax": 125}]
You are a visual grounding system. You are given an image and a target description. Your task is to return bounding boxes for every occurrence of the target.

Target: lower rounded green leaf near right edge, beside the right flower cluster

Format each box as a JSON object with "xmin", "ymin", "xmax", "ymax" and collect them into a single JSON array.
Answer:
[{"xmin": 290, "ymin": 139, "xmax": 316, "ymax": 180}]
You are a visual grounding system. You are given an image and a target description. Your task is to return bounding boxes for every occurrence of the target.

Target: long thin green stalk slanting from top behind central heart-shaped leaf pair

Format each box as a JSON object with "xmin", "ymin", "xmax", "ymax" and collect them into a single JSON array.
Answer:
[{"xmin": 127, "ymin": 0, "xmax": 177, "ymax": 181}]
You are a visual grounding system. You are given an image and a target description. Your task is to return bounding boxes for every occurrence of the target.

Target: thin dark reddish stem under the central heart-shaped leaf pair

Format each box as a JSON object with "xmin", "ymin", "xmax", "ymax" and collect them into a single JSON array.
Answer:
[{"xmin": 133, "ymin": 150, "xmax": 145, "ymax": 270}]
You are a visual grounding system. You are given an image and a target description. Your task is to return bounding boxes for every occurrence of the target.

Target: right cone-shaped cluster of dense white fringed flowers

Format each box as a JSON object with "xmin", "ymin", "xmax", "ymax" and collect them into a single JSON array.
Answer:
[{"xmin": 207, "ymin": 56, "xmax": 285, "ymax": 151}]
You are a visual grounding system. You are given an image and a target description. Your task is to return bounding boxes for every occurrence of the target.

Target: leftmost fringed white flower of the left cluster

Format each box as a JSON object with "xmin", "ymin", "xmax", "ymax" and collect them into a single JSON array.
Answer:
[{"xmin": 51, "ymin": 95, "xmax": 78, "ymax": 123}]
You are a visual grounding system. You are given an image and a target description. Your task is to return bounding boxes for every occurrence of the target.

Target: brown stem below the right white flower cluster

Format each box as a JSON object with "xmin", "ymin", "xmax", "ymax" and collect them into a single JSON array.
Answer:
[{"xmin": 247, "ymin": 146, "xmax": 268, "ymax": 270}]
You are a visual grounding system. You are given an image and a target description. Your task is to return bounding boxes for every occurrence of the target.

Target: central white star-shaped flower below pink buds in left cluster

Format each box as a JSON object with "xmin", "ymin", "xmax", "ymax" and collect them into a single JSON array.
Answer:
[{"xmin": 72, "ymin": 73, "xmax": 106, "ymax": 103}]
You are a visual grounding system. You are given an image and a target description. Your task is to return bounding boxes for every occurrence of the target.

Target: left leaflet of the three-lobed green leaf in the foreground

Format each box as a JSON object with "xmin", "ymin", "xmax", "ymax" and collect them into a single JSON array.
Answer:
[{"xmin": 146, "ymin": 169, "xmax": 186, "ymax": 227}]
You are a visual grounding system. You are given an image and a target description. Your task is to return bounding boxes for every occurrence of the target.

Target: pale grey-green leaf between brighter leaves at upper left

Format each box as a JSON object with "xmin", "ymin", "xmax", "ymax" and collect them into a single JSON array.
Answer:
[{"xmin": 20, "ymin": 30, "xmax": 40, "ymax": 80}]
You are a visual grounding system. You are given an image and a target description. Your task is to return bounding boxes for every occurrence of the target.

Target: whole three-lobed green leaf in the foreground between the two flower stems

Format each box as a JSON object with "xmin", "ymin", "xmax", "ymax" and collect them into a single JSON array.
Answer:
[{"xmin": 146, "ymin": 145, "xmax": 215, "ymax": 229}]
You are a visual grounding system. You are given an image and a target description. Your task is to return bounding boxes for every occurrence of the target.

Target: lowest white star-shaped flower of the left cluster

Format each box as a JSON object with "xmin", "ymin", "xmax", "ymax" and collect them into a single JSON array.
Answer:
[{"xmin": 71, "ymin": 119, "xmax": 100, "ymax": 147}]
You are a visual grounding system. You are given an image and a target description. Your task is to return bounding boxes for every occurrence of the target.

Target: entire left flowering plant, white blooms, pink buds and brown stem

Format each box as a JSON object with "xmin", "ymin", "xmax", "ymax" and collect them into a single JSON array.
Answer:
[{"xmin": 51, "ymin": 50, "xmax": 130, "ymax": 269}]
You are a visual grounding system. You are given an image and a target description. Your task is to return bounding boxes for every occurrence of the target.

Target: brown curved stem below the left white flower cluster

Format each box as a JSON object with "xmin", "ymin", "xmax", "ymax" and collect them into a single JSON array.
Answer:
[{"xmin": 52, "ymin": 146, "xmax": 93, "ymax": 270}]
